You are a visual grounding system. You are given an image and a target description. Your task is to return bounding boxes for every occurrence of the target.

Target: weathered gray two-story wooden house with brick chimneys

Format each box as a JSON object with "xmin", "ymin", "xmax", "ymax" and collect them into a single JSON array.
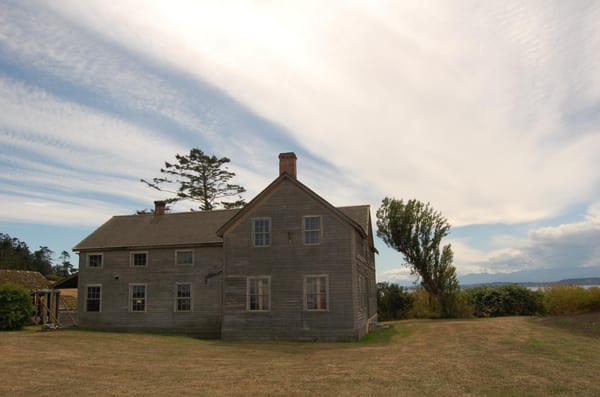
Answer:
[{"xmin": 74, "ymin": 153, "xmax": 377, "ymax": 340}]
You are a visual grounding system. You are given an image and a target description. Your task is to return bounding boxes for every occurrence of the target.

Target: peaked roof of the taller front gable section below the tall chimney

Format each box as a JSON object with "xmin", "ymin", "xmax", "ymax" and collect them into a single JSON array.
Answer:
[{"xmin": 217, "ymin": 172, "xmax": 370, "ymax": 237}]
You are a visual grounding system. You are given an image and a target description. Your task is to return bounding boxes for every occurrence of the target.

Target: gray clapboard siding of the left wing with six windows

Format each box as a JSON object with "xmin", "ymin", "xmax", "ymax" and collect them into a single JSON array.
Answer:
[{"xmin": 78, "ymin": 247, "xmax": 222, "ymax": 337}]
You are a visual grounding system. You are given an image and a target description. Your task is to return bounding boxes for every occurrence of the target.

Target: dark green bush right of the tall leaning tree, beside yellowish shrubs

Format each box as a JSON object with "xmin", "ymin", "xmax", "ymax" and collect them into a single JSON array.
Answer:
[{"xmin": 465, "ymin": 285, "xmax": 544, "ymax": 317}]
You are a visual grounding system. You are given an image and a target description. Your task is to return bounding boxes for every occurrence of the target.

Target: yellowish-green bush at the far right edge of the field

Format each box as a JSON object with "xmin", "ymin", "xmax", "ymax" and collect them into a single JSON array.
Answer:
[{"xmin": 544, "ymin": 284, "xmax": 600, "ymax": 315}]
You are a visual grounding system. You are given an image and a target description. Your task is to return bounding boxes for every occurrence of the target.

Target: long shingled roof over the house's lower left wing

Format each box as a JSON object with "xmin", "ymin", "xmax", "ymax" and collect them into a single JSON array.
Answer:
[{"xmin": 73, "ymin": 209, "xmax": 240, "ymax": 251}]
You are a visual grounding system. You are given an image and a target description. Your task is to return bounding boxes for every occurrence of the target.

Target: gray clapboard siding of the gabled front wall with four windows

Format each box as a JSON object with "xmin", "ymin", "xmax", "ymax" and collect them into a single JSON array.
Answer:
[{"xmin": 222, "ymin": 180, "xmax": 358, "ymax": 339}]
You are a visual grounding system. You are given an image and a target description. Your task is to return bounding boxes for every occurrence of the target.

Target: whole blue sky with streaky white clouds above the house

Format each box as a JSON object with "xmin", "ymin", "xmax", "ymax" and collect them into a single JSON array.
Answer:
[{"xmin": 0, "ymin": 0, "xmax": 600, "ymax": 283}]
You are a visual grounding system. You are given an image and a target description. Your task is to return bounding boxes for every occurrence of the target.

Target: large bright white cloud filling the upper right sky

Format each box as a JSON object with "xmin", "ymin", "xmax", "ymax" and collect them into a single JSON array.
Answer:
[{"xmin": 41, "ymin": 1, "xmax": 600, "ymax": 225}]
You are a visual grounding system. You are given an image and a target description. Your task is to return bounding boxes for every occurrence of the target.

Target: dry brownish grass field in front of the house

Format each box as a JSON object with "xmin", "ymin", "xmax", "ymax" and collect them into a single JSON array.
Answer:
[{"xmin": 0, "ymin": 317, "xmax": 600, "ymax": 396}]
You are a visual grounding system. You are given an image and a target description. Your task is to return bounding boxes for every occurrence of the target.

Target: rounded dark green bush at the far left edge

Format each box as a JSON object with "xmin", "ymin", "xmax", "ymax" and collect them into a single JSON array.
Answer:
[{"xmin": 0, "ymin": 283, "xmax": 33, "ymax": 331}]
